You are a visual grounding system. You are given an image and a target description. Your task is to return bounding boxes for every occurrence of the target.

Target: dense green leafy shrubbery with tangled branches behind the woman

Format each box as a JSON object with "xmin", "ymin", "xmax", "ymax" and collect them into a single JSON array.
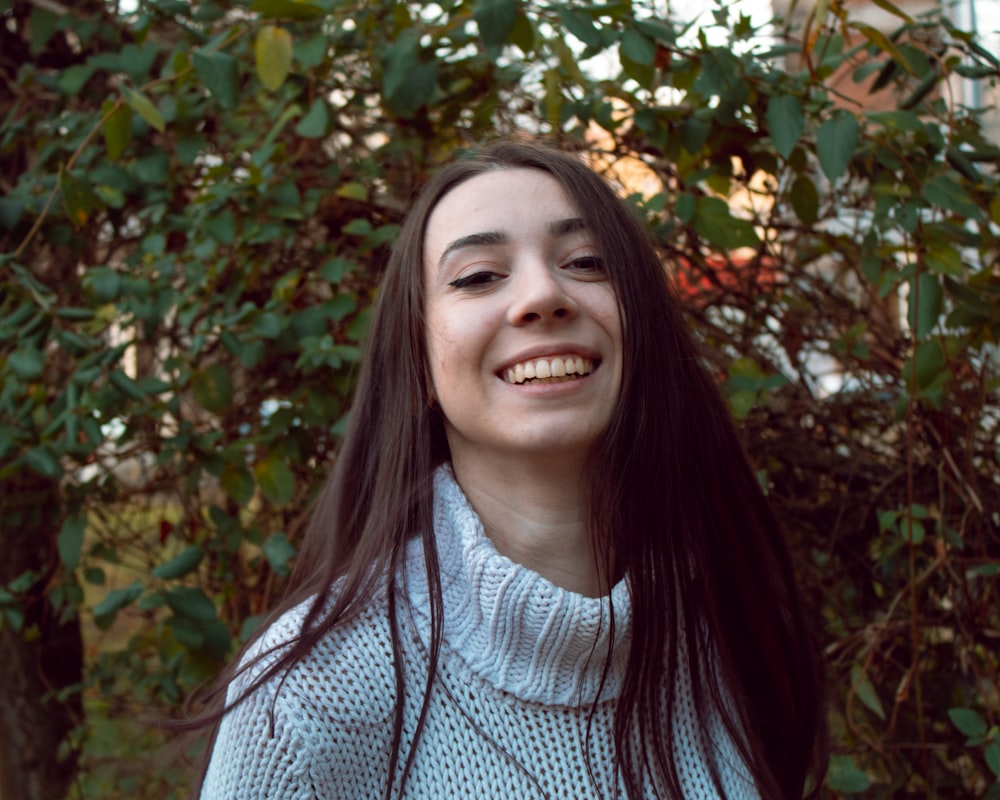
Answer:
[{"xmin": 0, "ymin": 0, "xmax": 1000, "ymax": 798}]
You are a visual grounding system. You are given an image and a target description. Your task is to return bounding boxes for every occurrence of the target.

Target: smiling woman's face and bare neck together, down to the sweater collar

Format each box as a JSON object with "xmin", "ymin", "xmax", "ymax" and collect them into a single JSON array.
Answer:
[{"xmin": 424, "ymin": 169, "xmax": 622, "ymax": 597}]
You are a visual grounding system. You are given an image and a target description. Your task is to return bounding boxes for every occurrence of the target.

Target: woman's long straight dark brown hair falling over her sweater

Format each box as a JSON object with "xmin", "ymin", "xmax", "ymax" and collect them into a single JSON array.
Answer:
[{"xmin": 191, "ymin": 141, "xmax": 825, "ymax": 800}]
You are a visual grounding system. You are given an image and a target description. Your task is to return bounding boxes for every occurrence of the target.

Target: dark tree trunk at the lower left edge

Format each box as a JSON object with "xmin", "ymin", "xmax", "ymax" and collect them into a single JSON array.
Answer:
[{"xmin": 0, "ymin": 472, "xmax": 83, "ymax": 800}]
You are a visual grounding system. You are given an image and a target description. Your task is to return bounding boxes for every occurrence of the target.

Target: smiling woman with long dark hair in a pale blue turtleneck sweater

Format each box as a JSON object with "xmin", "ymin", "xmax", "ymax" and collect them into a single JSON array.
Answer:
[{"xmin": 201, "ymin": 142, "xmax": 822, "ymax": 800}]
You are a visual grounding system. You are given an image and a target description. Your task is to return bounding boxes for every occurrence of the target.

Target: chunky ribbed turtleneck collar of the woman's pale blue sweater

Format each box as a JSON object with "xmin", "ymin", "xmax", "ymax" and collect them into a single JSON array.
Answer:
[{"xmin": 405, "ymin": 465, "xmax": 631, "ymax": 706}]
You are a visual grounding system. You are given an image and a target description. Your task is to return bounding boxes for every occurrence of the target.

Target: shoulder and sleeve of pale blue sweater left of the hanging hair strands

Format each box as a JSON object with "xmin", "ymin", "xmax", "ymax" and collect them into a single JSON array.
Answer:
[{"xmin": 200, "ymin": 600, "xmax": 394, "ymax": 800}]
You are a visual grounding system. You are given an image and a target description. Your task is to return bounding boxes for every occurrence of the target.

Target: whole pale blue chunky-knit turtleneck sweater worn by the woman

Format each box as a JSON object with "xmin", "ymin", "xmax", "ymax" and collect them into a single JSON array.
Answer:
[{"xmin": 201, "ymin": 467, "xmax": 758, "ymax": 800}]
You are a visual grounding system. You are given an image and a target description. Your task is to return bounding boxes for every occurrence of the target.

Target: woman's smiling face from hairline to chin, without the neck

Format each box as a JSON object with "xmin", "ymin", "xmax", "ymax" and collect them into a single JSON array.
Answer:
[{"xmin": 424, "ymin": 169, "xmax": 622, "ymax": 463}]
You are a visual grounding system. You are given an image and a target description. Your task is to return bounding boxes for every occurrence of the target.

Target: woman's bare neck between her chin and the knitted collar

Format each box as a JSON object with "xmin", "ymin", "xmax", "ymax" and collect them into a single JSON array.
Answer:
[{"xmin": 452, "ymin": 459, "xmax": 610, "ymax": 597}]
